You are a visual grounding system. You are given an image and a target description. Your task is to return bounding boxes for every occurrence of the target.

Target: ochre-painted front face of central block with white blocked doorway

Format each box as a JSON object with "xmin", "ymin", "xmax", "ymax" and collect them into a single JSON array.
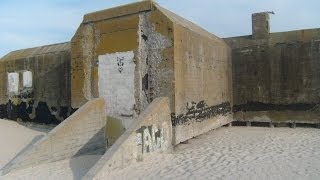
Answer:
[{"xmin": 71, "ymin": 1, "xmax": 174, "ymax": 131}]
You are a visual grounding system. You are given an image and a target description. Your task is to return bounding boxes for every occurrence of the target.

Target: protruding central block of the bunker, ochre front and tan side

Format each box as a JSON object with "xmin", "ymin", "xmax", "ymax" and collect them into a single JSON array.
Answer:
[{"xmin": 71, "ymin": 1, "xmax": 232, "ymax": 143}]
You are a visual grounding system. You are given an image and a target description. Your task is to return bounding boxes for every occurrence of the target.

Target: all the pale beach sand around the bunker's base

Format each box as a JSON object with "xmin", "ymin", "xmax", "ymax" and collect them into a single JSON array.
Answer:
[{"xmin": 0, "ymin": 121, "xmax": 320, "ymax": 180}]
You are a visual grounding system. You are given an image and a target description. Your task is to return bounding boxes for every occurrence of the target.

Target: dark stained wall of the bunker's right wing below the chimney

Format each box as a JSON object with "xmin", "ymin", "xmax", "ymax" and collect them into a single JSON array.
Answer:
[{"xmin": 226, "ymin": 29, "xmax": 320, "ymax": 123}]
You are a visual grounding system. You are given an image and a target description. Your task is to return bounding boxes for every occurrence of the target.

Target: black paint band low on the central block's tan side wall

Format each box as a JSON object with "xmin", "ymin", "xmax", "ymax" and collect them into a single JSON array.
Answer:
[{"xmin": 171, "ymin": 101, "xmax": 231, "ymax": 126}]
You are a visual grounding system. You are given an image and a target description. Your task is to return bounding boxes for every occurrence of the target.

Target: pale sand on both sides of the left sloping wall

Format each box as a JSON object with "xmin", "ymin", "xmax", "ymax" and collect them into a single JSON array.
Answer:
[{"xmin": 0, "ymin": 119, "xmax": 101, "ymax": 180}]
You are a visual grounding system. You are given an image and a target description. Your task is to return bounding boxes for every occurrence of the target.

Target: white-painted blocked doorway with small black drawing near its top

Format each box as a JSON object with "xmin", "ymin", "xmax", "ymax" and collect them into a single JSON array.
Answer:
[{"xmin": 98, "ymin": 51, "xmax": 135, "ymax": 117}]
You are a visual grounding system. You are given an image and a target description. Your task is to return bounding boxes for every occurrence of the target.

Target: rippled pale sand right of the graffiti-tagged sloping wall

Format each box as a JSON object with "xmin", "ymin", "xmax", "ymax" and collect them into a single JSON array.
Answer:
[{"xmin": 110, "ymin": 127, "xmax": 320, "ymax": 180}]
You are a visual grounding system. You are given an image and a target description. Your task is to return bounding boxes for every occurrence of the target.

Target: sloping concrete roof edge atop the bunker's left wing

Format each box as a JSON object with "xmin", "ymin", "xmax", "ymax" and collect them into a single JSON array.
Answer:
[{"xmin": 0, "ymin": 42, "xmax": 71, "ymax": 61}]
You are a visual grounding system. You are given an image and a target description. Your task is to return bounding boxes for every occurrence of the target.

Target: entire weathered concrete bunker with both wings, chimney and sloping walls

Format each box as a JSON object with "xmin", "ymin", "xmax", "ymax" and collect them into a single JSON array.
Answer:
[{"xmin": 0, "ymin": 1, "xmax": 320, "ymax": 179}]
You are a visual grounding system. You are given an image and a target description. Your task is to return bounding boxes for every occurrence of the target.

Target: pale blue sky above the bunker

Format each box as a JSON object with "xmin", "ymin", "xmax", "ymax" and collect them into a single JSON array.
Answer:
[{"xmin": 0, "ymin": 0, "xmax": 320, "ymax": 57}]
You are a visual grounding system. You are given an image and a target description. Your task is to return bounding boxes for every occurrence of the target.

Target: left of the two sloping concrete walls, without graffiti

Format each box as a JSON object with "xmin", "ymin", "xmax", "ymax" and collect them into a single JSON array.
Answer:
[{"xmin": 1, "ymin": 99, "xmax": 106, "ymax": 174}]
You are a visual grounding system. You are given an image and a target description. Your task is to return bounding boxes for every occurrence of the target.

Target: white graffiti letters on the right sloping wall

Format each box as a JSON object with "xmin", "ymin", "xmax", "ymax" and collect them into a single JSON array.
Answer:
[{"xmin": 136, "ymin": 125, "xmax": 164, "ymax": 153}]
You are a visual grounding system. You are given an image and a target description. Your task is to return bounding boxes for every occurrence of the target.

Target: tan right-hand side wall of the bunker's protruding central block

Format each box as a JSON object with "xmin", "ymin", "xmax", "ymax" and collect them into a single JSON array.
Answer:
[{"xmin": 161, "ymin": 5, "xmax": 232, "ymax": 144}]
